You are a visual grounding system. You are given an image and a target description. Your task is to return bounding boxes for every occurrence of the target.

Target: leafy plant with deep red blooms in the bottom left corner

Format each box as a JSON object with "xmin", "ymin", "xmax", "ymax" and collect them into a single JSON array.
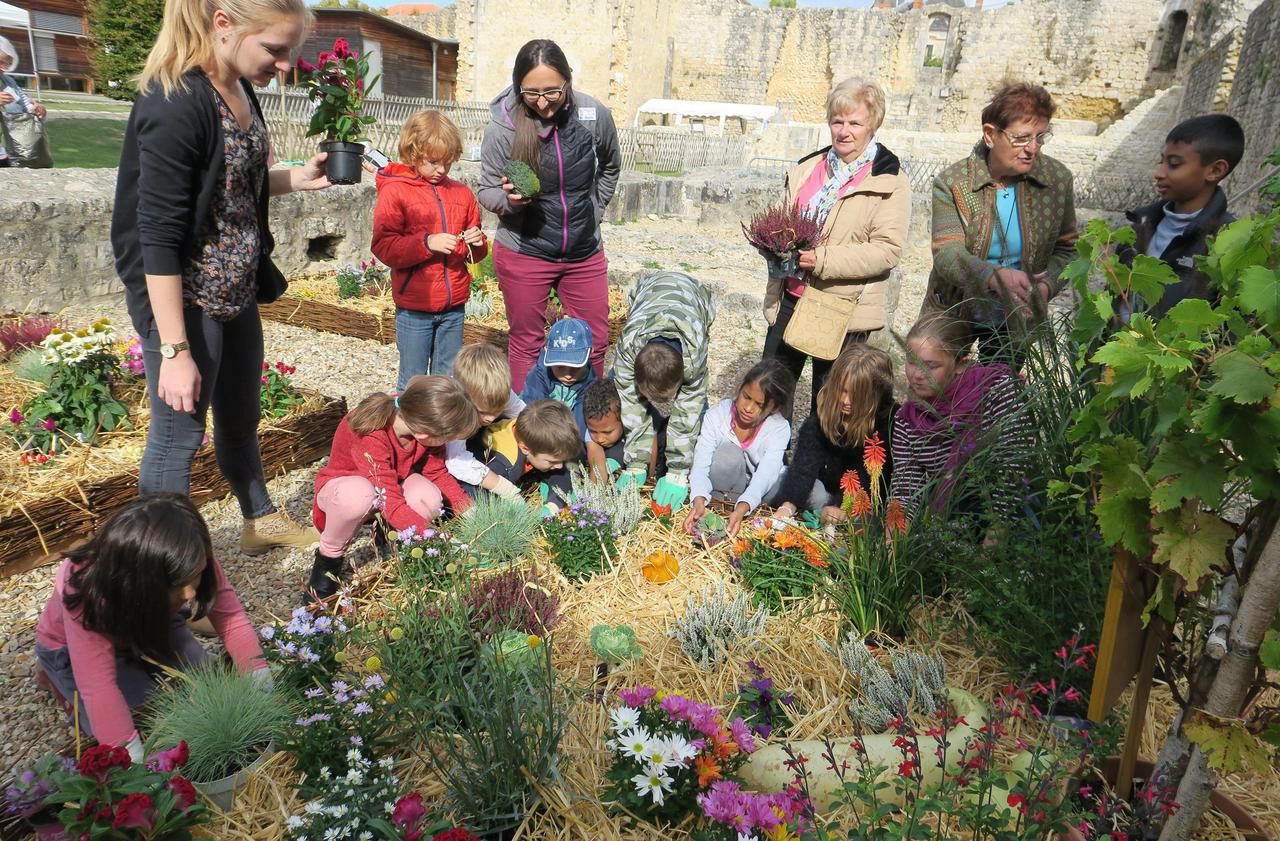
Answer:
[{"xmin": 45, "ymin": 742, "xmax": 209, "ymax": 841}]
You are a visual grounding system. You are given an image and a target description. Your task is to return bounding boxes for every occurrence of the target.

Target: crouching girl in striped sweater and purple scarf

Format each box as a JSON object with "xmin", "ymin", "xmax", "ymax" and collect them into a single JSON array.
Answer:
[{"xmin": 891, "ymin": 312, "xmax": 1034, "ymax": 543}]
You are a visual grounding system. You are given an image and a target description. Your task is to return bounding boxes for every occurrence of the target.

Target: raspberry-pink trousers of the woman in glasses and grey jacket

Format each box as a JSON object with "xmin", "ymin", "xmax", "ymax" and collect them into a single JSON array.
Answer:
[{"xmin": 493, "ymin": 242, "xmax": 609, "ymax": 394}]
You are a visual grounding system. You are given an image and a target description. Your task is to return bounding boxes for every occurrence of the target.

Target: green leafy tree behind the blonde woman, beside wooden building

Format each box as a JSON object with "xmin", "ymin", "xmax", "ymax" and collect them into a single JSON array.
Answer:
[{"xmin": 88, "ymin": 0, "xmax": 164, "ymax": 100}]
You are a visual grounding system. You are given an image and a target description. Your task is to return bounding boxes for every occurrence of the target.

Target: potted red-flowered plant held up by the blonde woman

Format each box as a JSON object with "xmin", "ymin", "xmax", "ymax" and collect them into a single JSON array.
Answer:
[{"xmin": 298, "ymin": 38, "xmax": 380, "ymax": 184}]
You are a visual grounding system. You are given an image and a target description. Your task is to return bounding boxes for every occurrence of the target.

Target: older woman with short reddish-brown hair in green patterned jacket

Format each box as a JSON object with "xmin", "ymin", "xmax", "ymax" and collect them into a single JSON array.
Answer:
[{"xmin": 922, "ymin": 82, "xmax": 1076, "ymax": 361}]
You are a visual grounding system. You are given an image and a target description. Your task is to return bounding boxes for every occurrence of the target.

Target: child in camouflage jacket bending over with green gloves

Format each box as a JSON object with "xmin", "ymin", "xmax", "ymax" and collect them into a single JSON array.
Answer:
[{"xmin": 613, "ymin": 271, "xmax": 716, "ymax": 511}]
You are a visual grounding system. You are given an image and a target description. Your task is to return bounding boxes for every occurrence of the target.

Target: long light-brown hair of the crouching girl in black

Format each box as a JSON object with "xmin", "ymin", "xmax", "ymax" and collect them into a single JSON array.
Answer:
[{"xmin": 818, "ymin": 344, "xmax": 893, "ymax": 447}]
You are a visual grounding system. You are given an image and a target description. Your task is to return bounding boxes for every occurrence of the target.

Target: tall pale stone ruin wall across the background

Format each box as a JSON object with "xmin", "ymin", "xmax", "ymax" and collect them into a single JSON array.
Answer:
[{"xmin": 404, "ymin": 0, "xmax": 1162, "ymax": 131}]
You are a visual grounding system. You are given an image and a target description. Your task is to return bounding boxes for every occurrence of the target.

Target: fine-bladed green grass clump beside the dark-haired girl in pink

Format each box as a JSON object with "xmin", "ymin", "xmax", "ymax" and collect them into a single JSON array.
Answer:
[{"xmin": 147, "ymin": 663, "xmax": 291, "ymax": 782}]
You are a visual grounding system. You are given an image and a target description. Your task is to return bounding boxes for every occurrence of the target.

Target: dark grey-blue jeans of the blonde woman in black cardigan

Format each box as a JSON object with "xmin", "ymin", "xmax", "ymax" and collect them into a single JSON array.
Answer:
[{"xmin": 138, "ymin": 301, "xmax": 275, "ymax": 518}]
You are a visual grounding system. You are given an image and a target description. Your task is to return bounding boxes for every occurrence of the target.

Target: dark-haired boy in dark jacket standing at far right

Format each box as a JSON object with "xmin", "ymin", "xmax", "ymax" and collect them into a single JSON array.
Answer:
[{"xmin": 1120, "ymin": 114, "xmax": 1244, "ymax": 317}]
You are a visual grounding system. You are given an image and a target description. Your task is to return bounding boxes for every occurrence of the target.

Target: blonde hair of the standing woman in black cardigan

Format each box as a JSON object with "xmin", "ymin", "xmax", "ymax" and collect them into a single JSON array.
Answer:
[{"xmin": 138, "ymin": 0, "xmax": 314, "ymax": 97}]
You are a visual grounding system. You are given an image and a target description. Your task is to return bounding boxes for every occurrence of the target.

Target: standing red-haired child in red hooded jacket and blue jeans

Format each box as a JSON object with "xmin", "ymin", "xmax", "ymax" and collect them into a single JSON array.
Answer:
[{"xmin": 372, "ymin": 111, "xmax": 489, "ymax": 390}]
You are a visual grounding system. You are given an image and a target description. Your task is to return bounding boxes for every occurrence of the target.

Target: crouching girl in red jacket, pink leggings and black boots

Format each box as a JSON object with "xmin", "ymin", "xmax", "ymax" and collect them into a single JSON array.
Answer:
[{"xmin": 303, "ymin": 376, "xmax": 480, "ymax": 600}]
